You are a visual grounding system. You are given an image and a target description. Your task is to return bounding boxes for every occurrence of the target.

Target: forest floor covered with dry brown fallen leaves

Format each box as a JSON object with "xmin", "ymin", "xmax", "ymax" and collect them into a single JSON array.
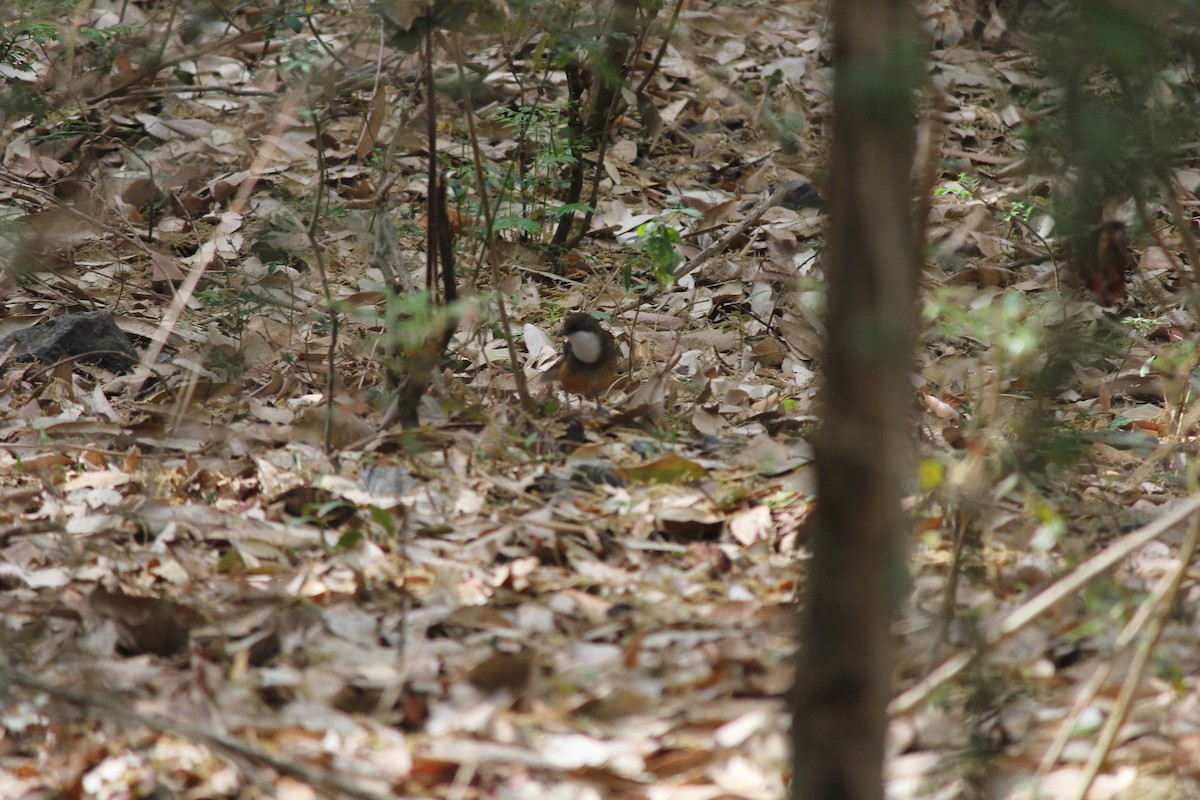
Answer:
[{"xmin": 0, "ymin": 0, "xmax": 1200, "ymax": 800}]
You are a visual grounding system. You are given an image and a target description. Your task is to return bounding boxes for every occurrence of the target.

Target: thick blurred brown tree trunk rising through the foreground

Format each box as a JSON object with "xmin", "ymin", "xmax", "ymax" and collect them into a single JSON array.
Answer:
[{"xmin": 792, "ymin": 0, "xmax": 923, "ymax": 800}]
